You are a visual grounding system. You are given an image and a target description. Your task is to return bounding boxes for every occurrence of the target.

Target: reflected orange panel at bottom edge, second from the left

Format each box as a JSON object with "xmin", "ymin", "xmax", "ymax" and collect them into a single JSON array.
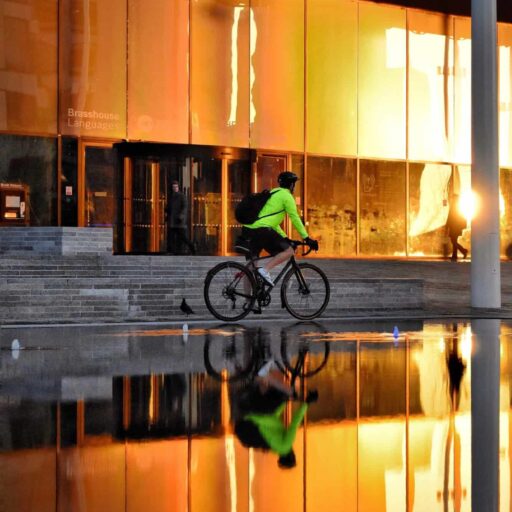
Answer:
[{"xmin": 57, "ymin": 444, "xmax": 125, "ymax": 512}]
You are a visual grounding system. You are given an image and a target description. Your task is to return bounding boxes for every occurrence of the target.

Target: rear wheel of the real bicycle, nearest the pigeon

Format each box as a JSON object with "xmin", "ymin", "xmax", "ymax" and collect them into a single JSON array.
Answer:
[{"xmin": 204, "ymin": 261, "xmax": 256, "ymax": 322}]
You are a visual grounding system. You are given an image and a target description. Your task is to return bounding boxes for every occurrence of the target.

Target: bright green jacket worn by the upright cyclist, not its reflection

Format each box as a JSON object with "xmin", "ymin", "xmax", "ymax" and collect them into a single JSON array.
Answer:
[{"xmin": 245, "ymin": 187, "xmax": 308, "ymax": 239}]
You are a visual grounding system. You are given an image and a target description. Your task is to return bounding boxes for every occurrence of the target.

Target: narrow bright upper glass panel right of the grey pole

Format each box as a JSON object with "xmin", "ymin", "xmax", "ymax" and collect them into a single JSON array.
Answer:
[{"xmin": 498, "ymin": 23, "xmax": 512, "ymax": 166}]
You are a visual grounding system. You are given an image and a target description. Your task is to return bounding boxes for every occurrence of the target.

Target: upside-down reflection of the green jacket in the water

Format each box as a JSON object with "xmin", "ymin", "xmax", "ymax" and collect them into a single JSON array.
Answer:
[{"xmin": 244, "ymin": 403, "xmax": 308, "ymax": 455}]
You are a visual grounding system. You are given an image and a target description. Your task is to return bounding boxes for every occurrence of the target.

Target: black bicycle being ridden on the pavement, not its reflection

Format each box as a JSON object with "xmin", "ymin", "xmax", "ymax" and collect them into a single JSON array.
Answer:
[{"xmin": 204, "ymin": 240, "xmax": 330, "ymax": 322}]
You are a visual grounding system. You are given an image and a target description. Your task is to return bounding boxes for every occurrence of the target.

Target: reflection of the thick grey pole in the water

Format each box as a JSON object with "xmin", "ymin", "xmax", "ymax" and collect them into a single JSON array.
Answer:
[{"xmin": 471, "ymin": 320, "xmax": 500, "ymax": 512}]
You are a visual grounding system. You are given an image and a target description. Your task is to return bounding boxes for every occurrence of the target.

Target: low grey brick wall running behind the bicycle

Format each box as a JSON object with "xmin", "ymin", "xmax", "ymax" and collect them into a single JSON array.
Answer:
[{"xmin": 0, "ymin": 251, "xmax": 424, "ymax": 324}]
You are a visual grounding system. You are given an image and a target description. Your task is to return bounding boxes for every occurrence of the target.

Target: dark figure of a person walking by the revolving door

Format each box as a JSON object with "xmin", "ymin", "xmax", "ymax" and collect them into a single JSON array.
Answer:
[{"xmin": 166, "ymin": 181, "xmax": 196, "ymax": 254}]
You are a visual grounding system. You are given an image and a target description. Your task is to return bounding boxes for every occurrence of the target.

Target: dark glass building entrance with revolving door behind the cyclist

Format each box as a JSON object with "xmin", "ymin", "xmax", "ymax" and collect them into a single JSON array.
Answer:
[{"xmin": 115, "ymin": 143, "xmax": 251, "ymax": 255}]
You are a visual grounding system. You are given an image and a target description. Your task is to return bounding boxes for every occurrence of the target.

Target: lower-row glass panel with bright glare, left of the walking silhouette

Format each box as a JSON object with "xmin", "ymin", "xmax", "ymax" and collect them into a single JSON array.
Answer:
[{"xmin": 409, "ymin": 163, "xmax": 452, "ymax": 256}]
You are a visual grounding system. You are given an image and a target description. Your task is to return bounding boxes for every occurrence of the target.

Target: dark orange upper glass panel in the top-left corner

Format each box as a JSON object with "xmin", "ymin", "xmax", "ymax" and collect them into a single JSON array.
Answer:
[{"xmin": 0, "ymin": 0, "xmax": 57, "ymax": 134}]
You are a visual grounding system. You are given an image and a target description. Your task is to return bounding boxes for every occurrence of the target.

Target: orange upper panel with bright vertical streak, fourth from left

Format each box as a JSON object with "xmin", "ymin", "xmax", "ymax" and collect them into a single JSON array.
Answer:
[{"xmin": 190, "ymin": 0, "xmax": 249, "ymax": 147}]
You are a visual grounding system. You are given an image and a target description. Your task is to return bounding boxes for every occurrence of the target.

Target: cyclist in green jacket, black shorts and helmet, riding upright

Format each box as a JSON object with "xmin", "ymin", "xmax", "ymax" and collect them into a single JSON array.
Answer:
[{"xmin": 242, "ymin": 171, "xmax": 318, "ymax": 286}]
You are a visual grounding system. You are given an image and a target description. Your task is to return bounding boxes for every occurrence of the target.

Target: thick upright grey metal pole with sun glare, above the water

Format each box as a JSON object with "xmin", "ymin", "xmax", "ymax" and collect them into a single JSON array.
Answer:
[{"xmin": 471, "ymin": 0, "xmax": 501, "ymax": 308}]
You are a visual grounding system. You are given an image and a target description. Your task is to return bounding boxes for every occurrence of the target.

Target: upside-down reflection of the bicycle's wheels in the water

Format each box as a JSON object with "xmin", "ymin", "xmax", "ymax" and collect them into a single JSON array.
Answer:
[{"xmin": 204, "ymin": 322, "xmax": 330, "ymax": 385}]
